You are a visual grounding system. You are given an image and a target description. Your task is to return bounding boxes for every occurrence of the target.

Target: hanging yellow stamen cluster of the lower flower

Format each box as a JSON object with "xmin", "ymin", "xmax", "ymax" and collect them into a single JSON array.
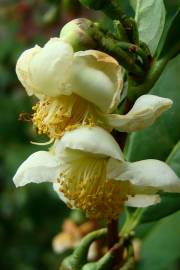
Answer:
[{"xmin": 59, "ymin": 150, "xmax": 128, "ymax": 220}]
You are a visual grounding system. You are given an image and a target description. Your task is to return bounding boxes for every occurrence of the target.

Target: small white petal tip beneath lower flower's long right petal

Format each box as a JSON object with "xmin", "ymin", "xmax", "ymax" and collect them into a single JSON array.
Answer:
[{"xmin": 125, "ymin": 194, "xmax": 161, "ymax": 207}]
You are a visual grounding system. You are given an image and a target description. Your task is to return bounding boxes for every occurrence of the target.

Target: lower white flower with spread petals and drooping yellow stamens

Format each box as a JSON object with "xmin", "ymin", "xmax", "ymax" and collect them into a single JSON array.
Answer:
[{"xmin": 13, "ymin": 127, "xmax": 180, "ymax": 220}]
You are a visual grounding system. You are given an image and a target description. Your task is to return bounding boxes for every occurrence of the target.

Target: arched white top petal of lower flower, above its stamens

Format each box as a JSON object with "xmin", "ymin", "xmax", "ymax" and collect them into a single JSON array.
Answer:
[{"xmin": 55, "ymin": 127, "xmax": 123, "ymax": 160}]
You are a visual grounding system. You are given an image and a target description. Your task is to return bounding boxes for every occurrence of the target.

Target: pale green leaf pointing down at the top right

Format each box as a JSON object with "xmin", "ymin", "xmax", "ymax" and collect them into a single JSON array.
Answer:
[{"xmin": 135, "ymin": 0, "xmax": 166, "ymax": 54}]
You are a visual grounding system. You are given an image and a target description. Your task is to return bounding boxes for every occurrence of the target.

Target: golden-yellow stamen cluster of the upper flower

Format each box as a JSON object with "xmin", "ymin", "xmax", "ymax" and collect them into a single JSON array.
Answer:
[{"xmin": 32, "ymin": 95, "xmax": 94, "ymax": 139}]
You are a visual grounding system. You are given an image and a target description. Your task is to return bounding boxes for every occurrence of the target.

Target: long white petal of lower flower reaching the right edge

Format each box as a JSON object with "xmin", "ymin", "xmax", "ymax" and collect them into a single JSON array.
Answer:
[{"xmin": 108, "ymin": 159, "xmax": 180, "ymax": 193}]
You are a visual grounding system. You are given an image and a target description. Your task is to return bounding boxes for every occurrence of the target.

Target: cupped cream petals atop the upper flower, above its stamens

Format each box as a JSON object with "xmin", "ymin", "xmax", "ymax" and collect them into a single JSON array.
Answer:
[{"xmin": 16, "ymin": 38, "xmax": 122, "ymax": 112}]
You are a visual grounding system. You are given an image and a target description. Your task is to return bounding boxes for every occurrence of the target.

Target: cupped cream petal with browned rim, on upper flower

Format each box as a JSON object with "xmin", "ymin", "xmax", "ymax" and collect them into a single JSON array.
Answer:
[{"xmin": 70, "ymin": 50, "xmax": 123, "ymax": 112}]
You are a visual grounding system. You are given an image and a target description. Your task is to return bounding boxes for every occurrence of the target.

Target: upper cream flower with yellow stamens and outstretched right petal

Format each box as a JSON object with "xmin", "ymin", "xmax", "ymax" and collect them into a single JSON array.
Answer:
[{"xmin": 16, "ymin": 38, "xmax": 172, "ymax": 139}]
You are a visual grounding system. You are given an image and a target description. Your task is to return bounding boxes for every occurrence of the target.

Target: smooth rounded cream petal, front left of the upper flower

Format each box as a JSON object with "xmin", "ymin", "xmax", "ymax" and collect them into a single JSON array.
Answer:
[{"xmin": 29, "ymin": 38, "xmax": 73, "ymax": 96}]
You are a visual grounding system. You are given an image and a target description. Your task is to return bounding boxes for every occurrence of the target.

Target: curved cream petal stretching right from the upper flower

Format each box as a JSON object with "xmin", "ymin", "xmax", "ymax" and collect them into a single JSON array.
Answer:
[{"xmin": 100, "ymin": 95, "xmax": 172, "ymax": 132}]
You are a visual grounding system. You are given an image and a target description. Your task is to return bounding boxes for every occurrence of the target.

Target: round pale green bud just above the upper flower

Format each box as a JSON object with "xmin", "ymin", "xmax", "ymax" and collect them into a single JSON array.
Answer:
[{"xmin": 60, "ymin": 18, "xmax": 96, "ymax": 51}]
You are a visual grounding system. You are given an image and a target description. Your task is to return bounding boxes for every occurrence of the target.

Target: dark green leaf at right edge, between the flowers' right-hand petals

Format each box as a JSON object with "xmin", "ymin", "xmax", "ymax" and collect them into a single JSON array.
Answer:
[{"xmin": 125, "ymin": 56, "xmax": 180, "ymax": 161}]
